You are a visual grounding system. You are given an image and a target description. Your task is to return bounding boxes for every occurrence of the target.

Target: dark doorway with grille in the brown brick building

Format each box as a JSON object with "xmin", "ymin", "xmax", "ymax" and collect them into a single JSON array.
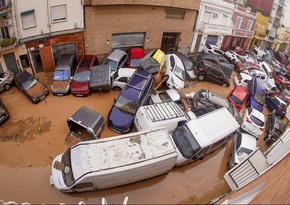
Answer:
[{"xmin": 161, "ymin": 33, "xmax": 181, "ymax": 54}]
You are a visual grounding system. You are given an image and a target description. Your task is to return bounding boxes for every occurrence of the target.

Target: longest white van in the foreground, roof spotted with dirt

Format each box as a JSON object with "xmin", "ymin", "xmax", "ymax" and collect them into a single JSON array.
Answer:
[{"xmin": 50, "ymin": 128, "xmax": 177, "ymax": 192}]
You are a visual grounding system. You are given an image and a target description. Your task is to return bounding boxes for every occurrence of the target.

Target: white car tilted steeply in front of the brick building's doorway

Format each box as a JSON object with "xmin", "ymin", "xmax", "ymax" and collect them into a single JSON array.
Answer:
[{"xmin": 165, "ymin": 54, "xmax": 185, "ymax": 89}]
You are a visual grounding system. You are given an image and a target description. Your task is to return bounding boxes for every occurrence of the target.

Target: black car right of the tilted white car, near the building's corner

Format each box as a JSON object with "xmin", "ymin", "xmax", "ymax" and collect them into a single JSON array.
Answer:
[{"xmin": 194, "ymin": 59, "xmax": 233, "ymax": 87}]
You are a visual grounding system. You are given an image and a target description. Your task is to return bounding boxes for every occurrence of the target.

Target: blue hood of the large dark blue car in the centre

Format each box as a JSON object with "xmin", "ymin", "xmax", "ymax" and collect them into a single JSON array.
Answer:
[{"xmin": 108, "ymin": 107, "xmax": 135, "ymax": 131}]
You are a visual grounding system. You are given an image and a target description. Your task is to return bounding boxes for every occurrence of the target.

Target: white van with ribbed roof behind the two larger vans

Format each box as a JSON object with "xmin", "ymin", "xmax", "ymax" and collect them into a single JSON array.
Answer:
[{"xmin": 134, "ymin": 101, "xmax": 196, "ymax": 132}]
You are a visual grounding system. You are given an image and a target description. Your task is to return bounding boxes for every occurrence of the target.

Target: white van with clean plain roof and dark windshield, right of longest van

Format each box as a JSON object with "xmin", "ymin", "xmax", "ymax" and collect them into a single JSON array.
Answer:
[{"xmin": 171, "ymin": 107, "xmax": 240, "ymax": 166}]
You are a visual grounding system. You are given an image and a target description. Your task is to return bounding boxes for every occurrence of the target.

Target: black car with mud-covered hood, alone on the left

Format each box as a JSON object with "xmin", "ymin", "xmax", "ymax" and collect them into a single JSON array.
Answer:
[{"xmin": 14, "ymin": 71, "xmax": 48, "ymax": 104}]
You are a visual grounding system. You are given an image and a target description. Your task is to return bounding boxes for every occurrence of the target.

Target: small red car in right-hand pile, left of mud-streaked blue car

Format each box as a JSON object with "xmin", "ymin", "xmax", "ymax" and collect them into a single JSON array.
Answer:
[{"xmin": 227, "ymin": 86, "xmax": 249, "ymax": 111}]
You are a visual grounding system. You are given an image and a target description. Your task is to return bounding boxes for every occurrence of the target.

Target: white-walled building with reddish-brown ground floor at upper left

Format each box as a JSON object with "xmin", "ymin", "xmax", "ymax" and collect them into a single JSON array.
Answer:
[{"xmin": 12, "ymin": 0, "xmax": 85, "ymax": 73}]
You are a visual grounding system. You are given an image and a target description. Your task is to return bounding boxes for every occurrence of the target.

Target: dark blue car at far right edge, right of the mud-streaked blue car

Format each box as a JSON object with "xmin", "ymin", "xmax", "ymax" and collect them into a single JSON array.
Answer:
[{"xmin": 265, "ymin": 96, "xmax": 287, "ymax": 118}]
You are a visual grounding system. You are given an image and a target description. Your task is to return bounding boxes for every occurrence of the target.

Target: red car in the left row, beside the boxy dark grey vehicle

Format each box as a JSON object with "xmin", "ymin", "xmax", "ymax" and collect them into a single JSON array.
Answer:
[{"xmin": 71, "ymin": 55, "xmax": 99, "ymax": 97}]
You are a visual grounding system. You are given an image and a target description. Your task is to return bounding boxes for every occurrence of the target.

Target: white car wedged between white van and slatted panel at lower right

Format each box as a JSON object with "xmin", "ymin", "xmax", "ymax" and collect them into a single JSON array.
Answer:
[{"xmin": 229, "ymin": 132, "xmax": 257, "ymax": 168}]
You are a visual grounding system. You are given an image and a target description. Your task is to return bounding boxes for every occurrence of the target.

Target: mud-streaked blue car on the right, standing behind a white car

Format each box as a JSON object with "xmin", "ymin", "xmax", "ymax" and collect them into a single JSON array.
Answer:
[{"xmin": 247, "ymin": 77, "xmax": 266, "ymax": 112}]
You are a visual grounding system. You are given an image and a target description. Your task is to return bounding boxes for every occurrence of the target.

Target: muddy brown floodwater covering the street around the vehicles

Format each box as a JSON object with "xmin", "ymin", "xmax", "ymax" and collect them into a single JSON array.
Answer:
[{"xmin": 0, "ymin": 73, "xmax": 236, "ymax": 204}]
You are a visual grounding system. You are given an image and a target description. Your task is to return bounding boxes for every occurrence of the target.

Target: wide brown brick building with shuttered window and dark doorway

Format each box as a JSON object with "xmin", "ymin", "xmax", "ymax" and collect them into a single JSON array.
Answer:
[{"xmin": 83, "ymin": 0, "xmax": 200, "ymax": 61}]
